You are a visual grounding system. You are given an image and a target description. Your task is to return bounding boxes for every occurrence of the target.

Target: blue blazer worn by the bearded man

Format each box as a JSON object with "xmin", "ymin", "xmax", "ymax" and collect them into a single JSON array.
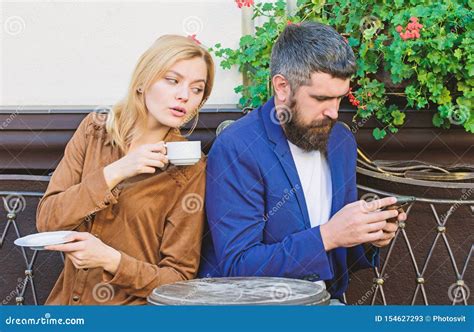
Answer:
[{"xmin": 199, "ymin": 98, "xmax": 378, "ymax": 299}]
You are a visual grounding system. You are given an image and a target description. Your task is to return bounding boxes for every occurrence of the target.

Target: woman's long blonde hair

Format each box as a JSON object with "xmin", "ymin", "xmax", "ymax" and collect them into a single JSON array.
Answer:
[{"xmin": 106, "ymin": 35, "xmax": 214, "ymax": 152}]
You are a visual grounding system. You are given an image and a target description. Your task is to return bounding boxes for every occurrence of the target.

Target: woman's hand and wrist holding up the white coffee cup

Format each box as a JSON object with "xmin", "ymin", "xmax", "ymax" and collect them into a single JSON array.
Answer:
[{"xmin": 104, "ymin": 141, "xmax": 168, "ymax": 189}]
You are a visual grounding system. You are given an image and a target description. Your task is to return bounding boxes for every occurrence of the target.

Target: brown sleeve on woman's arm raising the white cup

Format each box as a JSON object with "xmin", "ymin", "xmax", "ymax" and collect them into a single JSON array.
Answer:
[{"xmin": 36, "ymin": 114, "xmax": 119, "ymax": 232}]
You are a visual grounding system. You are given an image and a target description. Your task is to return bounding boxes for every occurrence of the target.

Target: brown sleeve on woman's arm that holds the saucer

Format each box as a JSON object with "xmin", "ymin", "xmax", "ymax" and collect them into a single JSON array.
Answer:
[{"xmin": 103, "ymin": 162, "xmax": 206, "ymax": 297}]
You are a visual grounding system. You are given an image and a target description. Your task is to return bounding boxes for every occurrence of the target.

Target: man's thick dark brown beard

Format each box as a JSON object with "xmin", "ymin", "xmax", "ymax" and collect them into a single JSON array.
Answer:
[{"xmin": 282, "ymin": 98, "xmax": 336, "ymax": 155}]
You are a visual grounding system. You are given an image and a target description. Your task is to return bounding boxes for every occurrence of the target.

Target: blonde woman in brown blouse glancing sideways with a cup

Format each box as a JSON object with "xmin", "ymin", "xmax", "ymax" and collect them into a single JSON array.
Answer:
[{"xmin": 37, "ymin": 35, "xmax": 214, "ymax": 304}]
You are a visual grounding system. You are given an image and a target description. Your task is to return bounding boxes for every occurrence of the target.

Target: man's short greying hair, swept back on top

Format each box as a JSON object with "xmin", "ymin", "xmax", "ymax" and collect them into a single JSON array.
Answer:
[{"xmin": 270, "ymin": 22, "xmax": 356, "ymax": 93}]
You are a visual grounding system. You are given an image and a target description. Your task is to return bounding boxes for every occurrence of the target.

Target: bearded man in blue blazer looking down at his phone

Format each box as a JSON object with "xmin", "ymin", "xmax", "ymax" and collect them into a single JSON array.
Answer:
[{"xmin": 199, "ymin": 23, "xmax": 406, "ymax": 304}]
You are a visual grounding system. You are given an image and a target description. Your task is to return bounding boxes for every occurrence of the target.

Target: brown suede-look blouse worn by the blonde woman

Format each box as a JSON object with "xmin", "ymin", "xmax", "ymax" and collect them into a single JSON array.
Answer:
[{"xmin": 36, "ymin": 114, "xmax": 205, "ymax": 304}]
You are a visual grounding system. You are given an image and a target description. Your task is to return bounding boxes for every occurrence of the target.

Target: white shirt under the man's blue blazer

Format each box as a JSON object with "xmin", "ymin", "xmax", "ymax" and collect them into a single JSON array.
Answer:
[{"xmin": 288, "ymin": 141, "xmax": 332, "ymax": 227}]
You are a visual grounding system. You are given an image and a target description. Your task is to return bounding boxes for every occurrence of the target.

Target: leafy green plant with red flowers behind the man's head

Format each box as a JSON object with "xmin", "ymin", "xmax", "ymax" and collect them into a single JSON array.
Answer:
[{"xmin": 212, "ymin": 0, "xmax": 474, "ymax": 139}]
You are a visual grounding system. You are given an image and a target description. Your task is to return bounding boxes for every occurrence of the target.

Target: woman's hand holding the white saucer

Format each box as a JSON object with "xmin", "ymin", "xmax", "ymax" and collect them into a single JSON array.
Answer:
[{"xmin": 45, "ymin": 232, "xmax": 121, "ymax": 274}]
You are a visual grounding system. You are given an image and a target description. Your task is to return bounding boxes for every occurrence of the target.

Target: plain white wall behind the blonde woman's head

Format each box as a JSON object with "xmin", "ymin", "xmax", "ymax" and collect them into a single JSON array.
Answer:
[{"xmin": 0, "ymin": 0, "xmax": 242, "ymax": 106}]
